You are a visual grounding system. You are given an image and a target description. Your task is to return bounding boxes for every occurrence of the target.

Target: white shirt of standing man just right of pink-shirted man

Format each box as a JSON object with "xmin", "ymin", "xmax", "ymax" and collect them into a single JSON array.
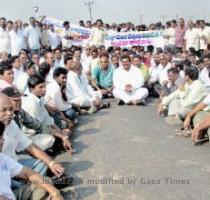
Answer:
[{"xmin": 184, "ymin": 28, "xmax": 200, "ymax": 51}]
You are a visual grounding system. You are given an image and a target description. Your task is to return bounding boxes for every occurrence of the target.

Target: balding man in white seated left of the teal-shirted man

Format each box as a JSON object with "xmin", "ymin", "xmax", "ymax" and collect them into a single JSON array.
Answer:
[{"xmin": 66, "ymin": 61, "xmax": 102, "ymax": 113}]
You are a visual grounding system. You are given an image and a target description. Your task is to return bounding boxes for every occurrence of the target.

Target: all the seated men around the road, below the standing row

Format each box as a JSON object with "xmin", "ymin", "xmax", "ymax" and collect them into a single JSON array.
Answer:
[{"xmin": 0, "ymin": 43, "xmax": 210, "ymax": 200}]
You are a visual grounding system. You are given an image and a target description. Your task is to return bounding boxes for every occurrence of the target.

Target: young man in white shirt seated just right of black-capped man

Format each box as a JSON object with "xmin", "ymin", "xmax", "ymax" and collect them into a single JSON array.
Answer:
[{"xmin": 22, "ymin": 75, "xmax": 71, "ymax": 152}]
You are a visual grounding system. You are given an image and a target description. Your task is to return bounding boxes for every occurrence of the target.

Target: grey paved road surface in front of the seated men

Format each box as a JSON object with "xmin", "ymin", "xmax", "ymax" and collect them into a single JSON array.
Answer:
[{"xmin": 58, "ymin": 102, "xmax": 210, "ymax": 200}]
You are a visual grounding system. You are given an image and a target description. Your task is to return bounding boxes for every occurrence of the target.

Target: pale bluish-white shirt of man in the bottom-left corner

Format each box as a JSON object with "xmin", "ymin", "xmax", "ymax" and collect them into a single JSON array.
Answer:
[{"xmin": 0, "ymin": 153, "xmax": 23, "ymax": 200}]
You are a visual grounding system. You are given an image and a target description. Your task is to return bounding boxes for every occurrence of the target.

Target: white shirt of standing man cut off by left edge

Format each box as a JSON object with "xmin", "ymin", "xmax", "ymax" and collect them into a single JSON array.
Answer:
[{"xmin": 0, "ymin": 27, "xmax": 11, "ymax": 54}]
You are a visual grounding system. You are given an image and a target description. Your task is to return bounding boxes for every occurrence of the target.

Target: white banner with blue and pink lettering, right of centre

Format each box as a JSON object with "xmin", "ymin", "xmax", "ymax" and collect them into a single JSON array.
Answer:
[{"xmin": 105, "ymin": 31, "xmax": 164, "ymax": 48}]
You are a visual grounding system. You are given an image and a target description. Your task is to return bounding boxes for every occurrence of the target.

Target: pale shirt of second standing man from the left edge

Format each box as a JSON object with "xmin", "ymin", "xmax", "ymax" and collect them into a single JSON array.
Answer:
[{"xmin": 9, "ymin": 30, "xmax": 26, "ymax": 56}]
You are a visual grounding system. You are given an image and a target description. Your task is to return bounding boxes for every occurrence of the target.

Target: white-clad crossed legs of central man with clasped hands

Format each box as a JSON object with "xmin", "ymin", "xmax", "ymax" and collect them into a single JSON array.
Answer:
[{"xmin": 113, "ymin": 88, "xmax": 149, "ymax": 103}]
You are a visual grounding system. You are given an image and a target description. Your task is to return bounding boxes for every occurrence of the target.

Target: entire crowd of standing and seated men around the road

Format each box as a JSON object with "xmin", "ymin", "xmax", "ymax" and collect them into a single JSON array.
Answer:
[{"xmin": 0, "ymin": 17, "xmax": 210, "ymax": 200}]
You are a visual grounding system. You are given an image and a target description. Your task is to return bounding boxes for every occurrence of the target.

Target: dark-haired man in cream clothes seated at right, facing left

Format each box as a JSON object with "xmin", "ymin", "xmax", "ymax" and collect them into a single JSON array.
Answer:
[{"xmin": 158, "ymin": 67, "xmax": 207, "ymax": 119}]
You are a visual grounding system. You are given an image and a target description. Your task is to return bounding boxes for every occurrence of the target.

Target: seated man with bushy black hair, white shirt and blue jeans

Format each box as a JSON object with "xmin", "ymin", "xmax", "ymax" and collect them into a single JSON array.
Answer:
[{"xmin": 45, "ymin": 67, "xmax": 78, "ymax": 124}]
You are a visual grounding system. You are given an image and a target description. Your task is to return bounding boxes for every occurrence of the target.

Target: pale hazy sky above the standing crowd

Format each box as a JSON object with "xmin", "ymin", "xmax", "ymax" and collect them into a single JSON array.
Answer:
[{"xmin": 0, "ymin": 0, "xmax": 210, "ymax": 24}]
